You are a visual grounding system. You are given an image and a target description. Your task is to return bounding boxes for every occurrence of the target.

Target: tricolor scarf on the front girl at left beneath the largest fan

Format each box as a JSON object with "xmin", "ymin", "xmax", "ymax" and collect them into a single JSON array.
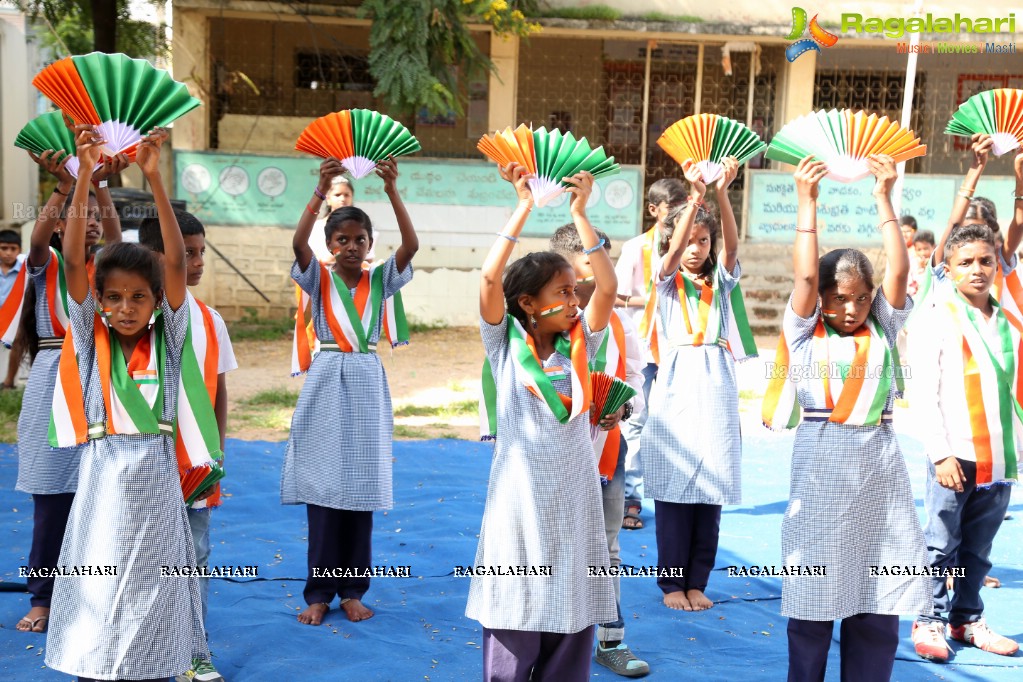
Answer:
[{"xmin": 49, "ymin": 309, "xmax": 174, "ymax": 448}]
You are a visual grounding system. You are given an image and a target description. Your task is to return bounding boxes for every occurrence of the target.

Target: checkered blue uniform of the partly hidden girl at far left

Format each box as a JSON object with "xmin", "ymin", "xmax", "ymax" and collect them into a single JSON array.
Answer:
[{"xmin": 15, "ymin": 254, "xmax": 81, "ymax": 495}]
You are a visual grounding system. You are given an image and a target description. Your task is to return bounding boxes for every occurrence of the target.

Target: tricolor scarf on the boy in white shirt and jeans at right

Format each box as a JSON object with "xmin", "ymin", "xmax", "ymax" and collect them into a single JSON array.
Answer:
[{"xmin": 945, "ymin": 291, "xmax": 1023, "ymax": 486}]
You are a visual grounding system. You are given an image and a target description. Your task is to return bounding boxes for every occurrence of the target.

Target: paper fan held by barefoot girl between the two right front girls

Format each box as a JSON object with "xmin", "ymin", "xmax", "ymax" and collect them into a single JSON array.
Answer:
[{"xmin": 657, "ymin": 113, "xmax": 767, "ymax": 184}]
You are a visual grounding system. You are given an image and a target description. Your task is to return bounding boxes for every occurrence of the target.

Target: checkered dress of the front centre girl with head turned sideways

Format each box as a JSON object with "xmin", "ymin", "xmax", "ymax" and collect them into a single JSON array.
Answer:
[{"xmin": 465, "ymin": 317, "xmax": 617, "ymax": 633}]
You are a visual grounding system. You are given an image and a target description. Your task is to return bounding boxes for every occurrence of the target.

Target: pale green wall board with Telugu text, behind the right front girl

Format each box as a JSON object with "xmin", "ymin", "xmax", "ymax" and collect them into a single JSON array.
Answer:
[{"xmin": 746, "ymin": 171, "xmax": 1015, "ymax": 246}]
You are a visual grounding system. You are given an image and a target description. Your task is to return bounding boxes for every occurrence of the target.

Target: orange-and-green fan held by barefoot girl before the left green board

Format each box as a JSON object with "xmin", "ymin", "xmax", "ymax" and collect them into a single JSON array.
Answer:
[{"xmin": 295, "ymin": 109, "xmax": 421, "ymax": 180}]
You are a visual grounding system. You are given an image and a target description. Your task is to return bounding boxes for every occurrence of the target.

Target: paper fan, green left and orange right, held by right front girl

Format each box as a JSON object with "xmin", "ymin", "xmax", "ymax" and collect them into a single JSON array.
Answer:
[{"xmin": 765, "ymin": 109, "xmax": 927, "ymax": 182}]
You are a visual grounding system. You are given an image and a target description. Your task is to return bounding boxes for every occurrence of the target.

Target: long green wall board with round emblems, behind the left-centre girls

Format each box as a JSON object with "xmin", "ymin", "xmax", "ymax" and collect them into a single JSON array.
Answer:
[{"xmin": 174, "ymin": 151, "xmax": 642, "ymax": 238}]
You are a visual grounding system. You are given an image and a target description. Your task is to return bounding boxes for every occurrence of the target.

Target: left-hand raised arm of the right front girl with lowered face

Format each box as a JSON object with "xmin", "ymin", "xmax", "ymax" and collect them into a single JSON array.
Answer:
[{"xmin": 792, "ymin": 156, "xmax": 828, "ymax": 317}]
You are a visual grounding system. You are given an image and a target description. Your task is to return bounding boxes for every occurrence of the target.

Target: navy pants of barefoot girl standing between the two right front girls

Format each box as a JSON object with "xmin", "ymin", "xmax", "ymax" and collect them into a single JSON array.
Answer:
[{"xmin": 654, "ymin": 500, "xmax": 721, "ymax": 594}]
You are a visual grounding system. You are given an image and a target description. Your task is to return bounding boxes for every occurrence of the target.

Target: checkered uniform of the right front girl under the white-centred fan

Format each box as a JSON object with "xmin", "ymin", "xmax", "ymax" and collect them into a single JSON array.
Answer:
[{"xmin": 782, "ymin": 287, "xmax": 932, "ymax": 621}]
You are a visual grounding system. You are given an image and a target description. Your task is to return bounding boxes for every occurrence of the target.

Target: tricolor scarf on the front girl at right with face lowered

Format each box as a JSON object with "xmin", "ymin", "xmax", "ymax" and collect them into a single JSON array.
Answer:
[{"xmin": 761, "ymin": 315, "xmax": 892, "ymax": 430}]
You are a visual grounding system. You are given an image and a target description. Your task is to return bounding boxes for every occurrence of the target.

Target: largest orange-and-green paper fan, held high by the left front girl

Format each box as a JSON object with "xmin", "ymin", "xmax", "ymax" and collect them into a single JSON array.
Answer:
[{"xmin": 32, "ymin": 52, "xmax": 201, "ymax": 156}]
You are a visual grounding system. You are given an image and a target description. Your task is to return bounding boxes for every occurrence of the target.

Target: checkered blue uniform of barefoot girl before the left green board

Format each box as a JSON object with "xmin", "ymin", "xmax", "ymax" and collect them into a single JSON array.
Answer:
[{"xmin": 280, "ymin": 255, "xmax": 412, "ymax": 511}]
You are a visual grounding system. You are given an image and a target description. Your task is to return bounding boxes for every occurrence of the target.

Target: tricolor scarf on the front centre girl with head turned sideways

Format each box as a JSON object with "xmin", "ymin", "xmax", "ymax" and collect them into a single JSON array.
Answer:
[{"xmin": 480, "ymin": 315, "xmax": 592, "ymax": 441}]
